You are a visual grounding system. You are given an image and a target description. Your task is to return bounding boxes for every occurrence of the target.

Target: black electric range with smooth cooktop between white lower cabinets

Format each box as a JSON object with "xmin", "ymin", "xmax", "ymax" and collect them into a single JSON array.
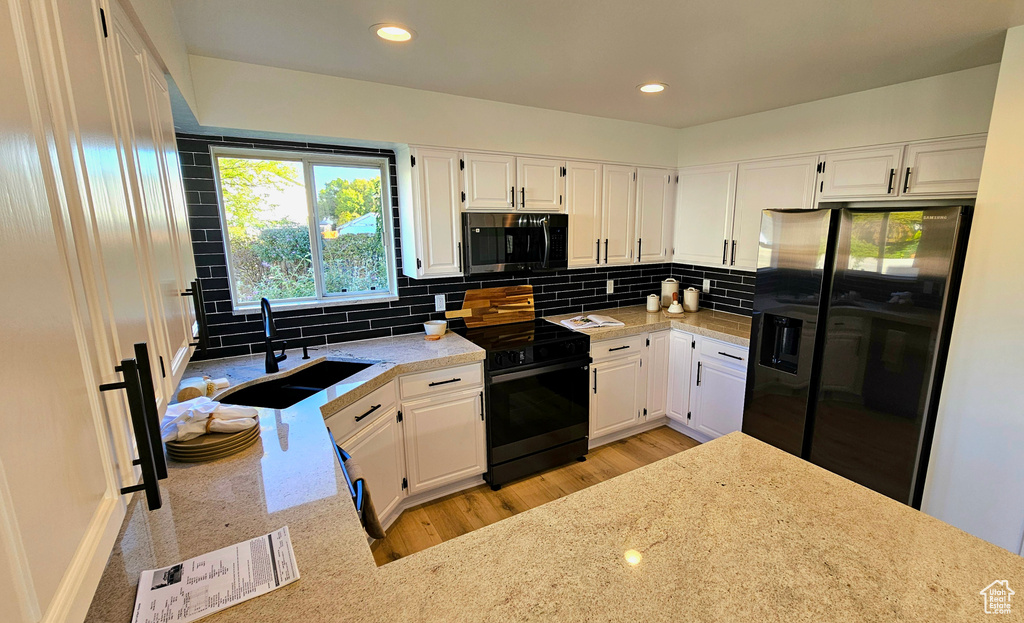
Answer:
[{"xmin": 455, "ymin": 320, "xmax": 591, "ymax": 490}]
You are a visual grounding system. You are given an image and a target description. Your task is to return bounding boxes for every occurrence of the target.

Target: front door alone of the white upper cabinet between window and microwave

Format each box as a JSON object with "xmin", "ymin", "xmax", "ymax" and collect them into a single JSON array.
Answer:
[{"xmin": 402, "ymin": 148, "xmax": 462, "ymax": 277}]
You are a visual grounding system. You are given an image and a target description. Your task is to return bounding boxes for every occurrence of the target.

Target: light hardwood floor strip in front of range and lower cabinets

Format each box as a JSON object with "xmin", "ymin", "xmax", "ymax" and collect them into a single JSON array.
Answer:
[{"xmin": 371, "ymin": 426, "xmax": 699, "ymax": 565}]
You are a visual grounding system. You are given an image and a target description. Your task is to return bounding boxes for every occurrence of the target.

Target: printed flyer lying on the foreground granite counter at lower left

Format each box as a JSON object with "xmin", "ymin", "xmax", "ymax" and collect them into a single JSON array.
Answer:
[{"xmin": 132, "ymin": 526, "xmax": 299, "ymax": 623}]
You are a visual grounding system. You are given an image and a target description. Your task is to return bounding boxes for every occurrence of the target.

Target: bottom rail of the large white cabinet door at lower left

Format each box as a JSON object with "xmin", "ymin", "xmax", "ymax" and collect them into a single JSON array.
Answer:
[{"xmin": 40, "ymin": 496, "xmax": 126, "ymax": 623}]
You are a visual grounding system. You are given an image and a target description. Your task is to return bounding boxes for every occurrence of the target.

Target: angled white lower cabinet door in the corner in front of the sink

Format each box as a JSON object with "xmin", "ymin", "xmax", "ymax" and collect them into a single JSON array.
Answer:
[{"xmin": 339, "ymin": 406, "xmax": 406, "ymax": 523}]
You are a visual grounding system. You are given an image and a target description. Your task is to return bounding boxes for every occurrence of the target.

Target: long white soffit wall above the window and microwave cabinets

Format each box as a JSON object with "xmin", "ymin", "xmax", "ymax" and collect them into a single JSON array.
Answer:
[{"xmin": 190, "ymin": 56, "xmax": 677, "ymax": 166}]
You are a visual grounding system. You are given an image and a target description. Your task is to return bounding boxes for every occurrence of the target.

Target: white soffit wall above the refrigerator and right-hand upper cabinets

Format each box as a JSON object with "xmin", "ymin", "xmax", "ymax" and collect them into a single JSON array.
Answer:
[{"xmin": 678, "ymin": 65, "xmax": 999, "ymax": 166}]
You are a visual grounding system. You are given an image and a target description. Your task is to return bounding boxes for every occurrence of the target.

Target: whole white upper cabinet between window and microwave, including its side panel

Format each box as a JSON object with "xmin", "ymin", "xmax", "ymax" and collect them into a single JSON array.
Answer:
[{"xmin": 398, "ymin": 148, "xmax": 462, "ymax": 279}]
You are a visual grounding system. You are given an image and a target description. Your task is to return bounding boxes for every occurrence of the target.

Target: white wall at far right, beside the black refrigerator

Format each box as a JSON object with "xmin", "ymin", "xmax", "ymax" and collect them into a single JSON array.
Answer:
[{"xmin": 923, "ymin": 27, "xmax": 1024, "ymax": 552}]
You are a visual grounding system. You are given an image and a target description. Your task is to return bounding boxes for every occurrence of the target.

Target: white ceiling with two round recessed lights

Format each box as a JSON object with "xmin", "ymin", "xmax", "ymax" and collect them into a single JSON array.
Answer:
[{"xmin": 172, "ymin": 0, "xmax": 1024, "ymax": 128}]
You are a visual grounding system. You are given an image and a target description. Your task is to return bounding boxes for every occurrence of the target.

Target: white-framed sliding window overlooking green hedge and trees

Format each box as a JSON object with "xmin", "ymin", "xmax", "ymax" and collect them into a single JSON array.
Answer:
[{"xmin": 213, "ymin": 148, "xmax": 397, "ymax": 312}]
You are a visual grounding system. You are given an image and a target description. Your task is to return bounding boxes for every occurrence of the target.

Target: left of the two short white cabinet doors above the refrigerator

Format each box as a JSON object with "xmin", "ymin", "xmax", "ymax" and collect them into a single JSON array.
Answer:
[{"xmin": 818, "ymin": 146, "xmax": 903, "ymax": 200}]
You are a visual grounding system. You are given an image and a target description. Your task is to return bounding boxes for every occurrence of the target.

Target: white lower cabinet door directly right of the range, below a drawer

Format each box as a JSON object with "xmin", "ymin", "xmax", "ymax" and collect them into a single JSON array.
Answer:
[{"xmin": 590, "ymin": 355, "xmax": 646, "ymax": 440}]
